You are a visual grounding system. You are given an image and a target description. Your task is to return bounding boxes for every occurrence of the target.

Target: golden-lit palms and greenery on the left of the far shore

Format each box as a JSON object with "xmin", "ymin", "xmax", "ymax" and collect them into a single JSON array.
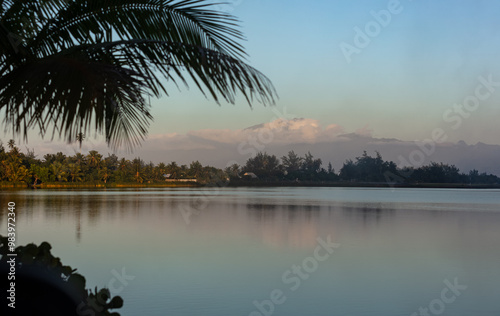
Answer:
[{"xmin": 0, "ymin": 140, "xmax": 225, "ymax": 185}]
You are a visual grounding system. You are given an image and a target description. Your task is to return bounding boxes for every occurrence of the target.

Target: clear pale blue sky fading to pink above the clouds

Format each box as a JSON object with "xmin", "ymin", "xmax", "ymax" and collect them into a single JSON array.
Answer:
[{"xmin": 3, "ymin": 0, "xmax": 500, "ymax": 168}]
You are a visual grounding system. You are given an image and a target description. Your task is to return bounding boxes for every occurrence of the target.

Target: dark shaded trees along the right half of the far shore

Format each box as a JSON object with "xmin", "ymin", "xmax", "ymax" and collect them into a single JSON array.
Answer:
[{"xmin": 235, "ymin": 151, "xmax": 500, "ymax": 184}]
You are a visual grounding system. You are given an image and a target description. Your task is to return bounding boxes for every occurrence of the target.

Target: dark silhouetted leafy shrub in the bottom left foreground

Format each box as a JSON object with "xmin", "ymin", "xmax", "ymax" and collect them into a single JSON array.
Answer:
[{"xmin": 0, "ymin": 235, "xmax": 123, "ymax": 316}]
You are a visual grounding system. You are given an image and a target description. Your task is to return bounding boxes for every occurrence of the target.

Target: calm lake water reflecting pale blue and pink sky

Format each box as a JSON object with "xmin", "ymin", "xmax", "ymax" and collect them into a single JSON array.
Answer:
[{"xmin": 0, "ymin": 188, "xmax": 500, "ymax": 316}]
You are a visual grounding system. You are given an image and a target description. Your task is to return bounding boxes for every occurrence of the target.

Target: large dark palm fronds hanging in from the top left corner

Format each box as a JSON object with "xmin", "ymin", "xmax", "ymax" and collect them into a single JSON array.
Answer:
[{"xmin": 0, "ymin": 0, "xmax": 276, "ymax": 148}]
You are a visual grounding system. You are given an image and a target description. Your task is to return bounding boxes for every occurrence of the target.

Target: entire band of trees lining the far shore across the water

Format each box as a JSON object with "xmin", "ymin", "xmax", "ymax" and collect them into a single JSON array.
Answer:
[{"xmin": 0, "ymin": 140, "xmax": 500, "ymax": 185}]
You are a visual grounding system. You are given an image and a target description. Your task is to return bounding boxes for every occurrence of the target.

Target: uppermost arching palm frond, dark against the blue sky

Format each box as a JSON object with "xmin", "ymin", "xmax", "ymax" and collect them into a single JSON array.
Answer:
[{"xmin": 33, "ymin": 0, "xmax": 244, "ymax": 57}]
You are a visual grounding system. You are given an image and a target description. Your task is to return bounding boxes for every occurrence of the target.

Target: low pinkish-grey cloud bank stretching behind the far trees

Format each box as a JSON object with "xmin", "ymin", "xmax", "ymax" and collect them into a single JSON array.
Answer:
[{"xmin": 16, "ymin": 118, "xmax": 500, "ymax": 175}]
